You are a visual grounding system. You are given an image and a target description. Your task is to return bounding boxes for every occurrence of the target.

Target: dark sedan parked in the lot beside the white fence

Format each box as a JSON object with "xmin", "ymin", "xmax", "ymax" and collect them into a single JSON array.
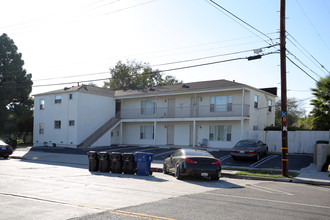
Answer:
[{"xmin": 231, "ymin": 140, "xmax": 268, "ymax": 160}]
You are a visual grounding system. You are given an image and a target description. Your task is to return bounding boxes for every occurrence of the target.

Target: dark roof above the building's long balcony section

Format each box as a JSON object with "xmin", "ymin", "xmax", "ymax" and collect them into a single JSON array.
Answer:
[{"xmin": 115, "ymin": 79, "xmax": 247, "ymax": 97}]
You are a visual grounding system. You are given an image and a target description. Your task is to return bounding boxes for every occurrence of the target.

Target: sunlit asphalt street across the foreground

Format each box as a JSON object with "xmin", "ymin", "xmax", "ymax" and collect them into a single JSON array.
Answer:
[{"xmin": 0, "ymin": 153, "xmax": 330, "ymax": 219}]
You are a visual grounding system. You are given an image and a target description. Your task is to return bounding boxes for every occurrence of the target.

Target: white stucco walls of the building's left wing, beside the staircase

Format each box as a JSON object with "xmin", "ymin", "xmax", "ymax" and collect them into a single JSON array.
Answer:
[{"xmin": 33, "ymin": 91, "xmax": 115, "ymax": 148}]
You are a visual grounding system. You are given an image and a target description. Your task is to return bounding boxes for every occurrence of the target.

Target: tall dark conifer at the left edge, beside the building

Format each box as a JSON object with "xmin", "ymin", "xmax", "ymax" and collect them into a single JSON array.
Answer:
[{"xmin": 0, "ymin": 34, "xmax": 33, "ymax": 141}]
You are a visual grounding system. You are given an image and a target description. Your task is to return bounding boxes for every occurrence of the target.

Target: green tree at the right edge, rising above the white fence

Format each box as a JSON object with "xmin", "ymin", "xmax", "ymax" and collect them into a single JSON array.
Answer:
[{"xmin": 311, "ymin": 74, "xmax": 330, "ymax": 130}]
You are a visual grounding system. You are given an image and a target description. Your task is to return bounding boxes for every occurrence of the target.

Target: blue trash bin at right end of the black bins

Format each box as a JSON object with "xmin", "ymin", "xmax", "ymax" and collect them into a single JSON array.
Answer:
[{"xmin": 134, "ymin": 152, "xmax": 153, "ymax": 176}]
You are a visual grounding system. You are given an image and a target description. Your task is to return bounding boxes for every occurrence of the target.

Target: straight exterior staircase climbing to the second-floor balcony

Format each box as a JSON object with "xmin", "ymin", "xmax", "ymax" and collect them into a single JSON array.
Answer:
[{"xmin": 77, "ymin": 113, "xmax": 120, "ymax": 148}]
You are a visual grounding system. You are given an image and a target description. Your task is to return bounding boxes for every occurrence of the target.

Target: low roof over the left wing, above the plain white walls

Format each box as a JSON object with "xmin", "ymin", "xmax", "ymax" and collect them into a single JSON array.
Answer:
[{"xmin": 34, "ymin": 85, "xmax": 115, "ymax": 97}]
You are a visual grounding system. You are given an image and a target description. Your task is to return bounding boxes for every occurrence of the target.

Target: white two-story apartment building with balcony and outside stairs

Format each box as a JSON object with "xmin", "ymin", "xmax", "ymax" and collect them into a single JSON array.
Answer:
[{"xmin": 34, "ymin": 80, "xmax": 276, "ymax": 149}]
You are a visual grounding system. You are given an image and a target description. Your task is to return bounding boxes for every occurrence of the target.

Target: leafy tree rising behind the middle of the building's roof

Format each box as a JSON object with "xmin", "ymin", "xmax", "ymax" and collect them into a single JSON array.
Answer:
[{"xmin": 103, "ymin": 61, "xmax": 182, "ymax": 90}]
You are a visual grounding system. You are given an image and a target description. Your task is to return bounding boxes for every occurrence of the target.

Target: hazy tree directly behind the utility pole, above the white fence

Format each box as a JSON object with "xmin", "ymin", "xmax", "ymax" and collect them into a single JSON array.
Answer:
[{"xmin": 275, "ymin": 98, "xmax": 305, "ymax": 127}]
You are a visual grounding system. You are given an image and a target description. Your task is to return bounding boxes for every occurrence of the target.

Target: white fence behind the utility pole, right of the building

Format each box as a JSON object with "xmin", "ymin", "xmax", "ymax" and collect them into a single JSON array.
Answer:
[{"xmin": 249, "ymin": 131, "xmax": 330, "ymax": 154}]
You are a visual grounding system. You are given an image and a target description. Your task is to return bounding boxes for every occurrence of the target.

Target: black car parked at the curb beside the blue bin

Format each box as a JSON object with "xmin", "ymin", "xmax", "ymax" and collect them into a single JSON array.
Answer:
[{"xmin": 163, "ymin": 149, "xmax": 221, "ymax": 180}]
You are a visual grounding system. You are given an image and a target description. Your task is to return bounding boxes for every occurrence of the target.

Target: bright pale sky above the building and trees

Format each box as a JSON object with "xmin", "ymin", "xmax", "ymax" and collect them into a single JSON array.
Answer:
[{"xmin": 0, "ymin": 0, "xmax": 330, "ymax": 111}]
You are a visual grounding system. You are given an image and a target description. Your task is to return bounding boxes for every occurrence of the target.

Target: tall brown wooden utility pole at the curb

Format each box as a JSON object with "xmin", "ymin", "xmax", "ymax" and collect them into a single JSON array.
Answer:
[{"xmin": 280, "ymin": 0, "xmax": 289, "ymax": 177}]
